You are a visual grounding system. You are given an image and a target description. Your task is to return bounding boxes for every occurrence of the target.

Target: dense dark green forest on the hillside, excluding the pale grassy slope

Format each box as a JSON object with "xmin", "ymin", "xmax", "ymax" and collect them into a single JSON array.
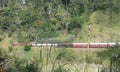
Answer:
[{"xmin": 0, "ymin": 0, "xmax": 120, "ymax": 42}]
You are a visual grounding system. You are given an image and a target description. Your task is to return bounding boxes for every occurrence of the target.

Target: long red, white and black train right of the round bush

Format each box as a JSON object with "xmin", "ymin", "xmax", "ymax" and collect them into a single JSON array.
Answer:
[{"xmin": 31, "ymin": 42, "xmax": 120, "ymax": 48}]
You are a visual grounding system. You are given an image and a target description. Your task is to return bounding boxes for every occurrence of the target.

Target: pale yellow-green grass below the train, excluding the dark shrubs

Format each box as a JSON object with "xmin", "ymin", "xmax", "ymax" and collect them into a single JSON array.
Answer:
[{"xmin": 2, "ymin": 47, "xmax": 99, "ymax": 72}]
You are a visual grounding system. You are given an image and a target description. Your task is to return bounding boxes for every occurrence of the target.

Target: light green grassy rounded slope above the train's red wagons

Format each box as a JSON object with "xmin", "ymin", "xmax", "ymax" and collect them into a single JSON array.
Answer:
[{"xmin": 82, "ymin": 11, "xmax": 120, "ymax": 42}]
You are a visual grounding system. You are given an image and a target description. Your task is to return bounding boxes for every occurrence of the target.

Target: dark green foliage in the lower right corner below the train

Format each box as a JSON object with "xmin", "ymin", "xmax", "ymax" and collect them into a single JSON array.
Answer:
[{"xmin": 98, "ymin": 44, "xmax": 120, "ymax": 71}]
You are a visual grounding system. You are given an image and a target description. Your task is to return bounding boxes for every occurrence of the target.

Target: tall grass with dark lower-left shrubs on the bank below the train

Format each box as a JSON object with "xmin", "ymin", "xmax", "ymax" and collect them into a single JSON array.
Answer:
[{"xmin": 0, "ymin": 47, "xmax": 106, "ymax": 72}]
